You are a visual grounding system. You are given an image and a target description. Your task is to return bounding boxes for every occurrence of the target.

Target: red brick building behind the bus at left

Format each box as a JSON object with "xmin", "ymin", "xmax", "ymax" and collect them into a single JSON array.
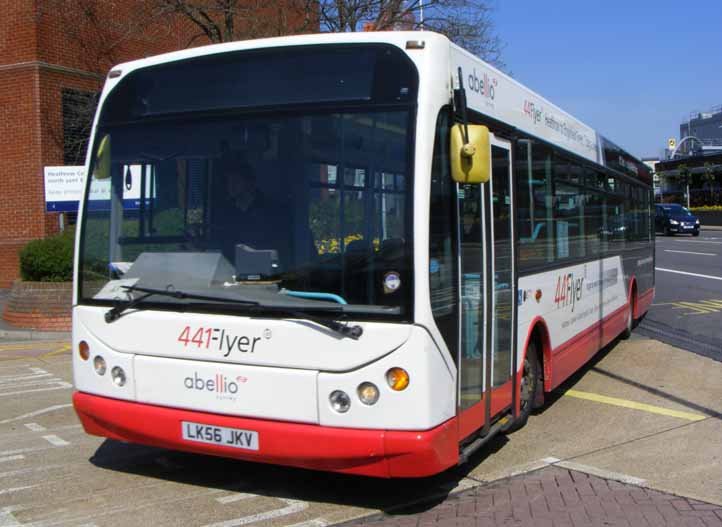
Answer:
[{"xmin": 0, "ymin": 0, "xmax": 318, "ymax": 287}]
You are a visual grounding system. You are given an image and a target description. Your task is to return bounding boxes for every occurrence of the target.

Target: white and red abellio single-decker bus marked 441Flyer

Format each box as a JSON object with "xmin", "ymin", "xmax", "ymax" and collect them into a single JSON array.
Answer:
[{"xmin": 73, "ymin": 32, "xmax": 654, "ymax": 477}]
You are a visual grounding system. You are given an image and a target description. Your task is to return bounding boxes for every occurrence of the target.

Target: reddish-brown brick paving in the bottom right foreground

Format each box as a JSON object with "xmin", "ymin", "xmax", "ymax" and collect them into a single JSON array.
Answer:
[{"xmin": 344, "ymin": 466, "xmax": 722, "ymax": 527}]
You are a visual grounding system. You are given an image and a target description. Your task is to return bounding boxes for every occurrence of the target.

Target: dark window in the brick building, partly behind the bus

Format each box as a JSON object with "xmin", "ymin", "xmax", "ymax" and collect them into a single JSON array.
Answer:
[{"xmin": 62, "ymin": 88, "xmax": 98, "ymax": 165}]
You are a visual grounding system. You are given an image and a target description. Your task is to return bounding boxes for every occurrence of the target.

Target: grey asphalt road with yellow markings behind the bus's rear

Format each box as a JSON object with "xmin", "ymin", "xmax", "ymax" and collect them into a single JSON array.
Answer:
[{"xmin": 639, "ymin": 230, "xmax": 722, "ymax": 361}]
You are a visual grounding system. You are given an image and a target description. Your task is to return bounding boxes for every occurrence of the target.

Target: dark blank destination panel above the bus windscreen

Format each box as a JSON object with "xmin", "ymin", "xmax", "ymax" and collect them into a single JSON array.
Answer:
[{"xmin": 102, "ymin": 44, "xmax": 418, "ymax": 124}]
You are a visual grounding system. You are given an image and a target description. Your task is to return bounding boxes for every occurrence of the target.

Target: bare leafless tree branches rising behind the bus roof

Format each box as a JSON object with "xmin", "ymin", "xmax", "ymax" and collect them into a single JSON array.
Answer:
[{"xmin": 145, "ymin": 0, "xmax": 504, "ymax": 67}]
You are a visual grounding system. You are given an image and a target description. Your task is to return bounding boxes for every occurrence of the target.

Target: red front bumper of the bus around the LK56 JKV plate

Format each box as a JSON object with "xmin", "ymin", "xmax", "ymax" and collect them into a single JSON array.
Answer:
[{"xmin": 73, "ymin": 392, "xmax": 459, "ymax": 478}]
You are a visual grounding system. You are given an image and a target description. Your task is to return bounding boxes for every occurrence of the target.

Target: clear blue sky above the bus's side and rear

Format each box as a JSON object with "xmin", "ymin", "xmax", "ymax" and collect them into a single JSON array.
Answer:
[{"xmin": 493, "ymin": 0, "xmax": 722, "ymax": 157}]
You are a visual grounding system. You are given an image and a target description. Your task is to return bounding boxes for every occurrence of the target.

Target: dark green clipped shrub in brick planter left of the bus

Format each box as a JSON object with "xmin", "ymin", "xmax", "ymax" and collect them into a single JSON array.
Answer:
[{"xmin": 20, "ymin": 230, "xmax": 74, "ymax": 282}]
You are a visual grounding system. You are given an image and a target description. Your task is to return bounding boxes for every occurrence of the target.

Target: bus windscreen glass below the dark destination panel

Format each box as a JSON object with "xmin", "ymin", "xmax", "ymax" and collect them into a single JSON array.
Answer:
[{"xmin": 81, "ymin": 110, "xmax": 411, "ymax": 314}]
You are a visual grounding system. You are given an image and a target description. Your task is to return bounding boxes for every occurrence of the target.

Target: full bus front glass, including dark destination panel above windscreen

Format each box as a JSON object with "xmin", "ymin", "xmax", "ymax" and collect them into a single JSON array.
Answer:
[{"xmin": 79, "ymin": 45, "xmax": 418, "ymax": 317}]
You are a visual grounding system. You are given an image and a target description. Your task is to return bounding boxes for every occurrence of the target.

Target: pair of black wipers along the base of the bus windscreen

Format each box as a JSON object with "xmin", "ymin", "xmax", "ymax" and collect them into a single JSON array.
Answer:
[{"xmin": 105, "ymin": 285, "xmax": 363, "ymax": 340}]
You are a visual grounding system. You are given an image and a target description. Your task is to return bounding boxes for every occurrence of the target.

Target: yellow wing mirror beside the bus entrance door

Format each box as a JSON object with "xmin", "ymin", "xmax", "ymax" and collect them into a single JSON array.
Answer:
[{"xmin": 450, "ymin": 124, "xmax": 491, "ymax": 184}]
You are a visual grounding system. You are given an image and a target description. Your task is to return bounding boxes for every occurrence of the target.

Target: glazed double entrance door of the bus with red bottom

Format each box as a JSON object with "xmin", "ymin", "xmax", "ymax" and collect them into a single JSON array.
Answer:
[{"xmin": 457, "ymin": 136, "xmax": 515, "ymax": 439}]
